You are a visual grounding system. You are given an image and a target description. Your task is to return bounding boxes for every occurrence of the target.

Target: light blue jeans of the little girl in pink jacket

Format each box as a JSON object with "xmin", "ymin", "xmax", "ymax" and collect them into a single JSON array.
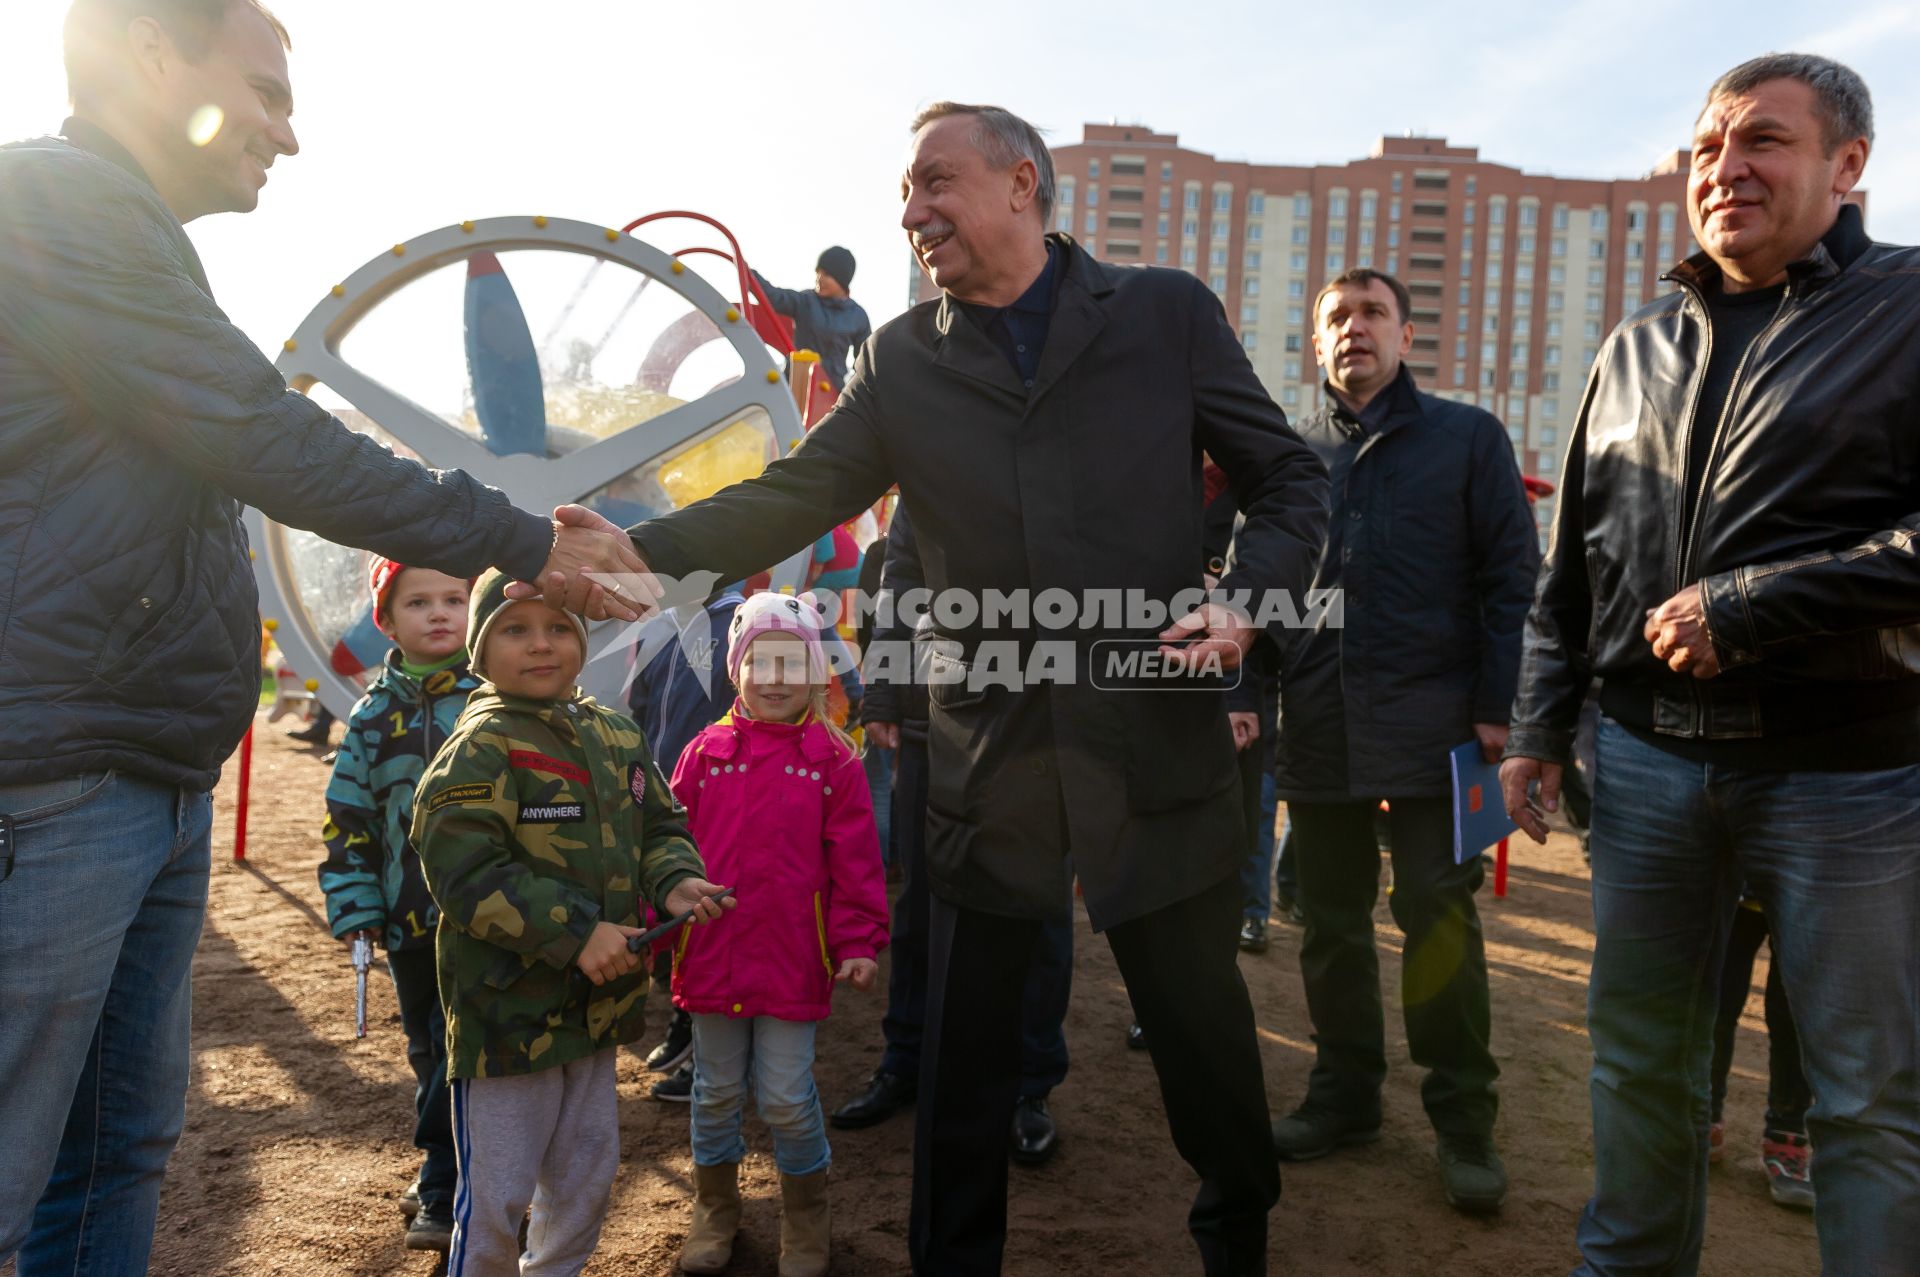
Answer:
[{"xmin": 693, "ymin": 1016, "xmax": 833, "ymax": 1175}]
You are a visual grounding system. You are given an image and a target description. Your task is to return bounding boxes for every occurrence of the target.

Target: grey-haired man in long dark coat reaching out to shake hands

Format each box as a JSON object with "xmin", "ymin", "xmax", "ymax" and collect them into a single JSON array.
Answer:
[{"xmin": 555, "ymin": 104, "xmax": 1327, "ymax": 1273}]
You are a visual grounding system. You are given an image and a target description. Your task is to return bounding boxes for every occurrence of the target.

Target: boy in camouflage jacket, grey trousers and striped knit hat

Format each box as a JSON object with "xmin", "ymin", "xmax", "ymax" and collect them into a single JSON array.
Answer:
[{"xmin": 413, "ymin": 572, "xmax": 732, "ymax": 1277}]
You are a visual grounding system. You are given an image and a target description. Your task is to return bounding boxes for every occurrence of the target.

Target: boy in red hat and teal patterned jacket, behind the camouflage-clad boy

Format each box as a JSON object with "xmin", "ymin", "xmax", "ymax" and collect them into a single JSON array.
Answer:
[{"xmin": 321, "ymin": 559, "xmax": 480, "ymax": 1250}]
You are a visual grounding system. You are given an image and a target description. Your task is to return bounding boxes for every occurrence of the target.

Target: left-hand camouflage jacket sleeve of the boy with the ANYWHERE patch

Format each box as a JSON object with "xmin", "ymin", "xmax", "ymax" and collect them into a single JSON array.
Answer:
[{"xmin": 413, "ymin": 732, "xmax": 601, "ymax": 970}]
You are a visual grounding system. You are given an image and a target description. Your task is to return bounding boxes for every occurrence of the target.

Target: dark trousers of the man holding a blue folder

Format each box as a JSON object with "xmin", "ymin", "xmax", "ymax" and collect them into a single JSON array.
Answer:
[{"xmin": 1286, "ymin": 799, "xmax": 1500, "ymax": 1135}]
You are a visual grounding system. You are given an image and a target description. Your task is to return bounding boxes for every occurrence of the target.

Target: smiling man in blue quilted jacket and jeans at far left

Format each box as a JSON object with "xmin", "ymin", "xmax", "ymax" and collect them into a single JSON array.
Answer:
[{"xmin": 0, "ymin": 0, "xmax": 637, "ymax": 1277}]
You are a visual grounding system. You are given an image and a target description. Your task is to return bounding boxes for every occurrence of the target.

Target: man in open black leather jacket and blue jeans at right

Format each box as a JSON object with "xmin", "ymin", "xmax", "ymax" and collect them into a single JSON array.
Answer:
[{"xmin": 1501, "ymin": 54, "xmax": 1920, "ymax": 1277}]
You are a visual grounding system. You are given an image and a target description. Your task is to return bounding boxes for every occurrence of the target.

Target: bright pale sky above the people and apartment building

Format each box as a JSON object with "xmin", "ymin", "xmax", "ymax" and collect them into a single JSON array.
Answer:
[{"xmin": 0, "ymin": 0, "xmax": 1920, "ymax": 368}]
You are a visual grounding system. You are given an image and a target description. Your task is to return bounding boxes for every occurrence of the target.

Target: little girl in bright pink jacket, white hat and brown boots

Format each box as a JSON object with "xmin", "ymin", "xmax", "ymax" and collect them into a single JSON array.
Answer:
[{"xmin": 672, "ymin": 593, "xmax": 887, "ymax": 1277}]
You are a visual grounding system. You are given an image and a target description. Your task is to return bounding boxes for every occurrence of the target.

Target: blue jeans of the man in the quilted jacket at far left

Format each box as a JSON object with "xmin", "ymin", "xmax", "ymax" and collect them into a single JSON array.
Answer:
[{"xmin": 0, "ymin": 772, "xmax": 213, "ymax": 1277}]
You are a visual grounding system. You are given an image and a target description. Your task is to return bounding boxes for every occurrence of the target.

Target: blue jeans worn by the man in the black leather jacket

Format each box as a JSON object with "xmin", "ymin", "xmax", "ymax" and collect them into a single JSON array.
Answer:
[{"xmin": 1576, "ymin": 718, "xmax": 1920, "ymax": 1277}]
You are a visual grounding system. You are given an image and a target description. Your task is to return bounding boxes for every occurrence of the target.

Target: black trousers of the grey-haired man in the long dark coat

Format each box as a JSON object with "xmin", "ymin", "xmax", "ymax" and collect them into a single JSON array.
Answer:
[{"xmin": 908, "ymin": 874, "xmax": 1281, "ymax": 1277}]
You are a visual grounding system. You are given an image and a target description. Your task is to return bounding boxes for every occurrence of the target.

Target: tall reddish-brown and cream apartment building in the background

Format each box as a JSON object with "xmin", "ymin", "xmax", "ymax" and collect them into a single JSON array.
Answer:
[{"xmin": 912, "ymin": 125, "xmax": 1866, "ymax": 526}]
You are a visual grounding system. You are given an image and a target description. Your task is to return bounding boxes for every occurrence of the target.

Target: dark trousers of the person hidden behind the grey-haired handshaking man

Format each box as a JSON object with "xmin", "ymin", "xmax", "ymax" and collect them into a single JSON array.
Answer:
[{"xmin": 879, "ymin": 737, "xmax": 1073, "ymax": 1098}]
